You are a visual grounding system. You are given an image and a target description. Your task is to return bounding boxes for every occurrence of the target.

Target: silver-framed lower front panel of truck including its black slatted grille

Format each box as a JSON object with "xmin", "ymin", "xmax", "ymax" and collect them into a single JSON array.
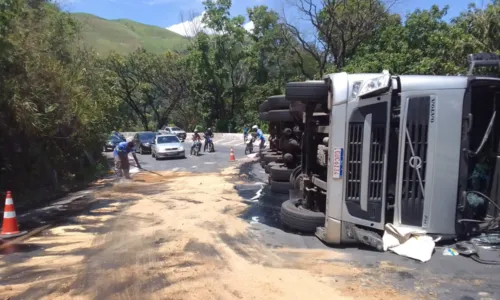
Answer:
[{"xmin": 342, "ymin": 92, "xmax": 391, "ymax": 230}]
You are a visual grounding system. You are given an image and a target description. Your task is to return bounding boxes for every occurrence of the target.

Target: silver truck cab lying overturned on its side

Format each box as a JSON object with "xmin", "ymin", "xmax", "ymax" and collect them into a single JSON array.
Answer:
[{"xmin": 281, "ymin": 55, "xmax": 500, "ymax": 250}]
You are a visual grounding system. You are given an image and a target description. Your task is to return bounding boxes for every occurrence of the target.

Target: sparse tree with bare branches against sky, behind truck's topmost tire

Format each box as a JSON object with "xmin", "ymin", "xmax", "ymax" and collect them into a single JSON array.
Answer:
[{"xmin": 287, "ymin": 0, "xmax": 397, "ymax": 72}]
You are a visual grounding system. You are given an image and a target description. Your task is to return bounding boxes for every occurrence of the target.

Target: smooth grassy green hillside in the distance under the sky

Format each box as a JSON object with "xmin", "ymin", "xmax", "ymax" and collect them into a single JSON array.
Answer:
[{"xmin": 72, "ymin": 13, "xmax": 187, "ymax": 55}]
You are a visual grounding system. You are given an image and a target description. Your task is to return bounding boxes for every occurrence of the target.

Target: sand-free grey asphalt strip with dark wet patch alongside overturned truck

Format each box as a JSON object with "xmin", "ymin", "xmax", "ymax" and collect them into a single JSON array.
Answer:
[{"xmin": 240, "ymin": 163, "xmax": 500, "ymax": 300}]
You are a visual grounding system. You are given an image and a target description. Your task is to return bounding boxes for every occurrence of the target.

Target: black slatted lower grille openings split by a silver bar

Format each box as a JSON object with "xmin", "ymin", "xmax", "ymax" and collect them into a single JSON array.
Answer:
[{"xmin": 346, "ymin": 118, "xmax": 386, "ymax": 222}]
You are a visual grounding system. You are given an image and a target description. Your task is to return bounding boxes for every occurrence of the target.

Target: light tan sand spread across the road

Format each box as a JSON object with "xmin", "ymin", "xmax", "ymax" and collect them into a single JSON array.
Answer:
[{"xmin": 0, "ymin": 167, "xmax": 416, "ymax": 300}]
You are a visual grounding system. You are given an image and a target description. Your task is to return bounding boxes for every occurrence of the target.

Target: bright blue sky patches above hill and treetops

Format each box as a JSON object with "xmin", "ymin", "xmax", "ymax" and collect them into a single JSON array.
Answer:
[{"xmin": 55, "ymin": 0, "xmax": 488, "ymax": 35}]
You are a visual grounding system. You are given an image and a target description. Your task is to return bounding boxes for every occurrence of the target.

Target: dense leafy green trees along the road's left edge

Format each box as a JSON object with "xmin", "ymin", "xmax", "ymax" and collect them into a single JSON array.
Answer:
[{"xmin": 0, "ymin": 0, "xmax": 124, "ymax": 205}]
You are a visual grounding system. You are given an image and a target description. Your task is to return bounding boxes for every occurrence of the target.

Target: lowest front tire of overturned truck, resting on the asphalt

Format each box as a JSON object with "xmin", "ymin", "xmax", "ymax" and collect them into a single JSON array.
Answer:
[{"xmin": 281, "ymin": 199, "xmax": 325, "ymax": 233}]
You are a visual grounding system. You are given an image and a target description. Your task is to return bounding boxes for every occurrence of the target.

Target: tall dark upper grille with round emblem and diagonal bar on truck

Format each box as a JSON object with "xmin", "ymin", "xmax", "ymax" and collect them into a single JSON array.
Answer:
[{"xmin": 401, "ymin": 96, "xmax": 430, "ymax": 226}]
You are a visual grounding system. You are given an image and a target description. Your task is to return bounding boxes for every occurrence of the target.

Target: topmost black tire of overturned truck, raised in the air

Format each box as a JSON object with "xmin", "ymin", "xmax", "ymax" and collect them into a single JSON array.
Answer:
[{"xmin": 285, "ymin": 81, "xmax": 330, "ymax": 103}]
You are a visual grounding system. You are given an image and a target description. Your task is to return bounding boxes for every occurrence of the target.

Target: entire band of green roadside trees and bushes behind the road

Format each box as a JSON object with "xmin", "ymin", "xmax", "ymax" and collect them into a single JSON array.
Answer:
[{"xmin": 0, "ymin": 0, "xmax": 500, "ymax": 205}]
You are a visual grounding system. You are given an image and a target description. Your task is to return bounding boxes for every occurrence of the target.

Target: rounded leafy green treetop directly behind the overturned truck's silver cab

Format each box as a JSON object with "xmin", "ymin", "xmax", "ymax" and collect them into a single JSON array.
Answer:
[{"xmin": 346, "ymin": 6, "xmax": 481, "ymax": 75}]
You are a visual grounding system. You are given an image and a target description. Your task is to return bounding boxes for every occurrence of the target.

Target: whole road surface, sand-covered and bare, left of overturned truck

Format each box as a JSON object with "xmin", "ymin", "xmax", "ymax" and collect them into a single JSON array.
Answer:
[{"xmin": 0, "ymin": 143, "xmax": 500, "ymax": 300}]
